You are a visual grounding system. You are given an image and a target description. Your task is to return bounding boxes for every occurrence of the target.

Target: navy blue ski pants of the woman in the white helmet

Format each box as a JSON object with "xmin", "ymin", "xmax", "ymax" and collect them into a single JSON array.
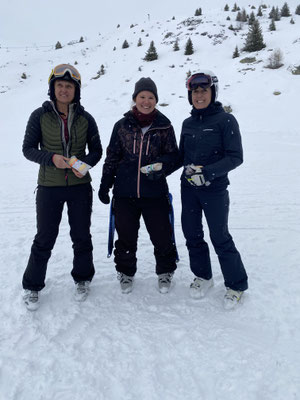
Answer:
[{"xmin": 181, "ymin": 185, "xmax": 248, "ymax": 290}]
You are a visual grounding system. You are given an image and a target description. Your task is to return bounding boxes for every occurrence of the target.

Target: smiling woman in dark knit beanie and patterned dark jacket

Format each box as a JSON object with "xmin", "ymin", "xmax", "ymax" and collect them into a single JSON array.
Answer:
[{"xmin": 99, "ymin": 78, "xmax": 178, "ymax": 293}]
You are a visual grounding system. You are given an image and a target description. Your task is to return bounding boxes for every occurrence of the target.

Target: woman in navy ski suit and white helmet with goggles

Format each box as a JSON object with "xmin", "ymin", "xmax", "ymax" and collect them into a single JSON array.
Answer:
[{"xmin": 179, "ymin": 71, "xmax": 248, "ymax": 309}]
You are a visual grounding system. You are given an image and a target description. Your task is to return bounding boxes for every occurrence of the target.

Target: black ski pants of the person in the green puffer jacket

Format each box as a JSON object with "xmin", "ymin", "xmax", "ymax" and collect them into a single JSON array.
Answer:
[{"xmin": 23, "ymin": 183, "xmax": 95, "ymax": 291}]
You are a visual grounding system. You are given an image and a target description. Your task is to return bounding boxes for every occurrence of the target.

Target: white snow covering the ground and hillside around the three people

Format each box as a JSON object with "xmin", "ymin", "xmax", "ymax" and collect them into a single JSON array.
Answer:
[{"xmin": 0, "ymin": 0, "xmax": 300, "ymax": 400}]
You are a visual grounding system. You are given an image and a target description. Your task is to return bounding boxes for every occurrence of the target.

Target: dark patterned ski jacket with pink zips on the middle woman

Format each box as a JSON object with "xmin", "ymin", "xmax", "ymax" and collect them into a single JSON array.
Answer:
[{"xmin": 101, "ymin": 111, "xmax": 179, "ymax": 198}]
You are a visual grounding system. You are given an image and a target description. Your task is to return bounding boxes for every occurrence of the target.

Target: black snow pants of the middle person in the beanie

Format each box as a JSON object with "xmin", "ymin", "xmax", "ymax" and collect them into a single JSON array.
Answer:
[{"xmin": 113, "ymin": 196, "xmax": 176, "ymax": 276}]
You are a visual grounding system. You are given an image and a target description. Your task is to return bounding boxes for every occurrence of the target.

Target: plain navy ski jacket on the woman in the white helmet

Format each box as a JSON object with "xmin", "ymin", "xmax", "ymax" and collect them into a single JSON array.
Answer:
[{"xmin": 179, "ymin": 102, "xmax": 243, "ymax": 191}]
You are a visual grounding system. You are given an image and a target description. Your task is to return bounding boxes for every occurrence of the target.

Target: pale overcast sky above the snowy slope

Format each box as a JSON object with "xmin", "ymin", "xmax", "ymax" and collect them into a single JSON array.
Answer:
[{"xmin": 0, "ymin": 0, "xmax": 198, "ymax": 47}]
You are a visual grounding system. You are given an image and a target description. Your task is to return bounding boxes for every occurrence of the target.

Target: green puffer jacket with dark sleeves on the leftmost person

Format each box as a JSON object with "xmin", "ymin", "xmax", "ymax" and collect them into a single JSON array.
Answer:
[{"xmin": 23, "ymin": 101, "xmax": 102, "ymax": 186}]
